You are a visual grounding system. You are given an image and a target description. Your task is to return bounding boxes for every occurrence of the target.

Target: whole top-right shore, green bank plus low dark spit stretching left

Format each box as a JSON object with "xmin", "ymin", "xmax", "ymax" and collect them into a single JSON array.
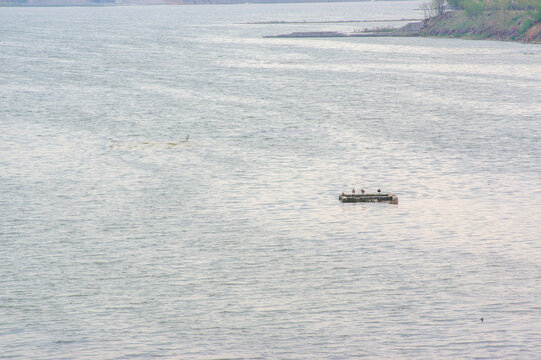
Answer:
[{"xmin": 264, "ymin": 0, "xmax": 541, "ymax": 44}]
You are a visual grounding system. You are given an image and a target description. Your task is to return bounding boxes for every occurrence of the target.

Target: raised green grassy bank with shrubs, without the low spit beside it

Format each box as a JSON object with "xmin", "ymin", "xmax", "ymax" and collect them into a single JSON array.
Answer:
[{"xmin": 421, "ymin": 0, "xmax": 541, "ymax": 44}]
